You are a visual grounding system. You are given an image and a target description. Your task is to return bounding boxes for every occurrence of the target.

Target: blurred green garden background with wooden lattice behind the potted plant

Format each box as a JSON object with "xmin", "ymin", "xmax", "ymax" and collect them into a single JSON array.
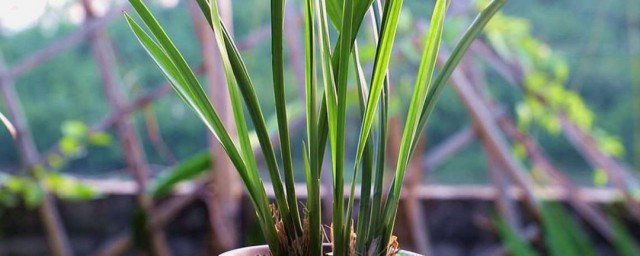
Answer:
[{"xmin": 0, "ymin": 0, "xmax": 640, "ymax": 256}]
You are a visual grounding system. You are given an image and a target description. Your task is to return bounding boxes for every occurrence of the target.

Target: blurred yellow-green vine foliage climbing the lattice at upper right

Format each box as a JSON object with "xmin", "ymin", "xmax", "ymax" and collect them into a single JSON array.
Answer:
[{"xmin": 486, "ymin": 13, "xmax": 624, "ymax": 160}]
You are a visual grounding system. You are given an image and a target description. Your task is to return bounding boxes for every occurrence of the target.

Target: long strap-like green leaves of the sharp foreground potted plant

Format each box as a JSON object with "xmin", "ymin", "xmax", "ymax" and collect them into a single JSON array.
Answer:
[{"xmin": 125, "ymin": 0, "xmax": 506, "ymax": 255}]
